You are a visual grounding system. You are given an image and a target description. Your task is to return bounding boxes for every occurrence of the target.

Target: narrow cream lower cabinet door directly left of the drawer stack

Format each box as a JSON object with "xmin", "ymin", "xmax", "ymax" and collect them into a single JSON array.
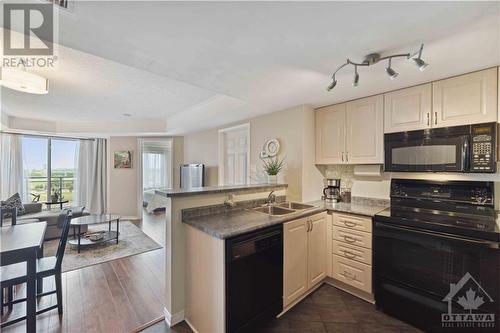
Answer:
[{"xmin": 307, "ymin": 213, "xmax": 331, "ymax": 289}]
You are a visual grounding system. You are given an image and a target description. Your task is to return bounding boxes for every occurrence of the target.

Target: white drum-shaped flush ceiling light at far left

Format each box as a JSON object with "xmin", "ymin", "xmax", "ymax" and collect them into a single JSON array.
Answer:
[{"xmin": 0, "ymin": 68, "xmax": 49, "ymax": 94}]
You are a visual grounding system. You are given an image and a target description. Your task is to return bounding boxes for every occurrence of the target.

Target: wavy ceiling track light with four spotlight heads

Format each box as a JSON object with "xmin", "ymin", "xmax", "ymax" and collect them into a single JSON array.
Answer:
[{"xmin": 326, "ymin": 44, "xmax": 429, "ymax": 91}]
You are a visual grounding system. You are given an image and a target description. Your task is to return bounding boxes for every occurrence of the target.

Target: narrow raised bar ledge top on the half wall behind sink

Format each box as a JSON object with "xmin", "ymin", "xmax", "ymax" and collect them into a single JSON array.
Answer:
[{"xmin": 155, "ymin": 184, "xmax": 288, "ymax": 198}]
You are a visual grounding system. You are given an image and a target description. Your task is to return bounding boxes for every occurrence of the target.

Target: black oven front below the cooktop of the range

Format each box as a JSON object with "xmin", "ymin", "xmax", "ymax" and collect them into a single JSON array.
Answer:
[{"xmin": 373, "ymin": 222, "xmax": 500, "ymax": 331}]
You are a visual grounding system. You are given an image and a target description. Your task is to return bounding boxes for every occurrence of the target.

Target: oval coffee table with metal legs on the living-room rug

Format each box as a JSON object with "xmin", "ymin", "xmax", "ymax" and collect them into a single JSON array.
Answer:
[{"xmin": 68, "ymin": 214, "xmax": 121, "ymax": 253}]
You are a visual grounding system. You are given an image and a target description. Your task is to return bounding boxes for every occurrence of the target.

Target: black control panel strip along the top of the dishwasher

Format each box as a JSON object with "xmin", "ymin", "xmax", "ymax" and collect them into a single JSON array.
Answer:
[{"xmin": 229, "ymin": 230, "xmax": 283, "ymax": 261}]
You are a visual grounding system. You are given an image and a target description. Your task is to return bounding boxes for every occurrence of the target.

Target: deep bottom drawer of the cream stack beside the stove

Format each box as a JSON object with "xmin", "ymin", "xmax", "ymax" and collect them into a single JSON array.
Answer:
[{"xmin": 333, "ymin": 254, "xmax": 372, "ymax": 294}]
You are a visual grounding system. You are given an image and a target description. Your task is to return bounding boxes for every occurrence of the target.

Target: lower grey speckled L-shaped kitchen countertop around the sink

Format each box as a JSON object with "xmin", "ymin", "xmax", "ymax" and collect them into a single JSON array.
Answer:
[{"xmin": 182, "ymin": 198, "xmax": 389, "ymax": 239}]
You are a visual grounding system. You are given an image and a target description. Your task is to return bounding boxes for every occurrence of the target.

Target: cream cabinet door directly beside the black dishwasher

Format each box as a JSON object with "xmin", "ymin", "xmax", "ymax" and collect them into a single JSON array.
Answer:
[{"xmin": 283, "ymin": 219, "xmax": 308, "ymax": 307}]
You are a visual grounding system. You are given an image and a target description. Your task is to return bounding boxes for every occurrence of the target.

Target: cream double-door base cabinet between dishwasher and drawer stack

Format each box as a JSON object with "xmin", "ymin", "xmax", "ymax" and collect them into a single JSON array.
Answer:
[{"xmin": 283, "ymin": 212, "xmax": 328, "ymax": 308}]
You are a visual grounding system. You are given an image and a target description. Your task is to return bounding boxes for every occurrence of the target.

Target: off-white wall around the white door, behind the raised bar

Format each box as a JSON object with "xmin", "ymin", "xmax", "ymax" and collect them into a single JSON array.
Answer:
[{"xmin": 184, "ymin": 106, "xmax": 323, "ymax": 201}]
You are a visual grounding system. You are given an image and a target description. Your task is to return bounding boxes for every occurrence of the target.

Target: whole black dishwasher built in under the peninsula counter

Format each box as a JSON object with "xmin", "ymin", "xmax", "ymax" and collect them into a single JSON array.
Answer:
[{"xmin": 226, "ymin": 225, "xmax": 283, "ymax": 333}]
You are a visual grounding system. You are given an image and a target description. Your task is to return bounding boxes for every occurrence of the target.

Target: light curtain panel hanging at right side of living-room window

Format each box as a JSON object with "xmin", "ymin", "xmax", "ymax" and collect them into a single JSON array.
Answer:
[{"xmin": 74, "ymin": 139, "xmax": 108, "ymax": 214}]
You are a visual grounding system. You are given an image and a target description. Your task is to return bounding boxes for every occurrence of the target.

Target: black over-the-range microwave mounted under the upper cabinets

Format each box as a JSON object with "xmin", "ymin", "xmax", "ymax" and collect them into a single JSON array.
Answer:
[{"xmin": 384, "ymin": 123, "xmax": 499, "ymax": 173}]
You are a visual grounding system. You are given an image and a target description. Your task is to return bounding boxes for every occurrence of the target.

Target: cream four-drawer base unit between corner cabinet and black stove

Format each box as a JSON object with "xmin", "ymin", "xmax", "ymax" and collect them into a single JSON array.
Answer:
[{"xmin": 328, "ymin": 213, "xmax": 372, "ymax": 294}]
